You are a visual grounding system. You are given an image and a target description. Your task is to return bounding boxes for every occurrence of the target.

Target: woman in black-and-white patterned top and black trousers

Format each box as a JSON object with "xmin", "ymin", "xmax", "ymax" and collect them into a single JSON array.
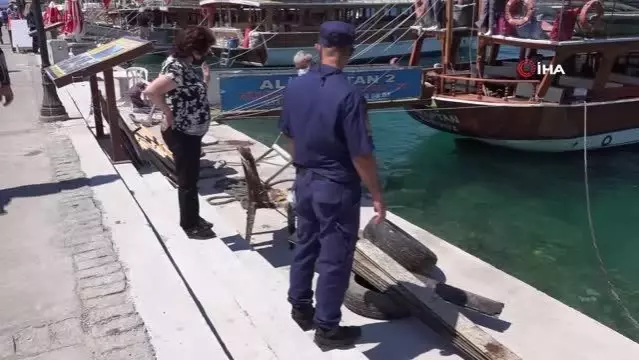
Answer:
[{"xmin": 144, "ymin": 26, "xmax": 216, "ymax": 239}]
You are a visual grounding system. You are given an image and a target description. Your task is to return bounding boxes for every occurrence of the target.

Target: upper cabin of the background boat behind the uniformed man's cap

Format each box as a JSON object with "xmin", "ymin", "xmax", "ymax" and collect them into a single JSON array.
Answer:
[{"xmin": 200, "ymin": 0, "xmax": 413, "ymax": 48}]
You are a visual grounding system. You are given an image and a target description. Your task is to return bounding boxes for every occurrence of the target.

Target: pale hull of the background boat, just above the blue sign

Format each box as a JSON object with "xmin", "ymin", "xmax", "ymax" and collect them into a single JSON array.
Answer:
[{"xmin": 265, "ymin": 38, "xmax": 469, "ymax": 66}]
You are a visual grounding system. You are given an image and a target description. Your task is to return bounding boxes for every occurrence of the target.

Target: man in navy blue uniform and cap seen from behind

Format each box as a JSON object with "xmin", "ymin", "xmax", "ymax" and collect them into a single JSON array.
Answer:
[{"xmin": 279, "ymin": 21, "xmax": 385, "ymax": 348}]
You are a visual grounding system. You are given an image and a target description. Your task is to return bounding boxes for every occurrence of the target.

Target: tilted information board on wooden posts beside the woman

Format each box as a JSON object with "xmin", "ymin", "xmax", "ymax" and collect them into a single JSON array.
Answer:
[{"xmin": 45, "ymin": 36, "xmax": 153, "ymax": 87}]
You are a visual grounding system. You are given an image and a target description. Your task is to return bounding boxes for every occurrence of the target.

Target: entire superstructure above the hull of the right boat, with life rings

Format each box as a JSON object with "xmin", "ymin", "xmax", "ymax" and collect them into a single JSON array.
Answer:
[{"xmin": 413, "ymin": 0, "xmax": 639, "ymax": 104}]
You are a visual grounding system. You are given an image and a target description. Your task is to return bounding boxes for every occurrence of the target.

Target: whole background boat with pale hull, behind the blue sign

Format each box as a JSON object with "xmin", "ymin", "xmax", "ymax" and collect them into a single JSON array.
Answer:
[{"xmin": 200, "ymin": 0, "xmax": 476, "ymax": 66}]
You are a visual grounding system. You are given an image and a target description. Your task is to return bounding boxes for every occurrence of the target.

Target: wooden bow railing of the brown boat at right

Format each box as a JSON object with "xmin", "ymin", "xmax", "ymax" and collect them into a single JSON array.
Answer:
[{"xmin": 426, "ymin": 73, "xmax": 541, "ymax": 100}]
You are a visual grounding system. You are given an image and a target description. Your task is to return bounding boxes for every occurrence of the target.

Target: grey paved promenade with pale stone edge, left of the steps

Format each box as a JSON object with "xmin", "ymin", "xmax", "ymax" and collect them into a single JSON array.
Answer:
[{"xmin": 0, "ymin": 41, "xmax": 228, "ymax": 360}]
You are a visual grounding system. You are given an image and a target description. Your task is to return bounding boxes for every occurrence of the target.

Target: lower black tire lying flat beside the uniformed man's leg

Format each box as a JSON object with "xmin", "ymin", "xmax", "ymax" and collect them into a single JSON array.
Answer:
[{"xmin": 344, "ymin": 273, "xmax": 410, "ymax": 320}]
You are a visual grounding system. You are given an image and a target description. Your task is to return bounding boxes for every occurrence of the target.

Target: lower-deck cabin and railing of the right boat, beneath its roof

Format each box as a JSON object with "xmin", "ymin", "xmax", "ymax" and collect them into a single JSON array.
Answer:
[{"xmin": 426, "ymin": 36, "xmax": 639, "ymax": 104}]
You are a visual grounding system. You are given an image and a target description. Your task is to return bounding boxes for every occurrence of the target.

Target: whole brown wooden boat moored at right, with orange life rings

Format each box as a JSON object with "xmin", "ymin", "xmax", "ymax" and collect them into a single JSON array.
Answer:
[{"xmin": 407, "ymin": 0, "xmax": 639, "ymax": 152}]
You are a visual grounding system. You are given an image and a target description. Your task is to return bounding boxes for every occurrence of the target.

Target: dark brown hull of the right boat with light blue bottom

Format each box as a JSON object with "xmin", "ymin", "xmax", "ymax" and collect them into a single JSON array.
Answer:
[{"xmin": 407, "ymin": 96, "xmax": 639, "ymax": 152}]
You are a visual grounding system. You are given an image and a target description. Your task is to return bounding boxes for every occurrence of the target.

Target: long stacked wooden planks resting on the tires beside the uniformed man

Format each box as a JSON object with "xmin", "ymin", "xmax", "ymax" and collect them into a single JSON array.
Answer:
[{"xmin": 354, "ymin": 239, "xmax": 520, "ymax": 360}]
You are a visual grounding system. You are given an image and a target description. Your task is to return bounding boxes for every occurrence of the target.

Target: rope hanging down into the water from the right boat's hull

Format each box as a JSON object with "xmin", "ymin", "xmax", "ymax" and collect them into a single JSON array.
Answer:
[{"xmin": 583, "ymin": 101, "xmax": 639, "ymax": 329}]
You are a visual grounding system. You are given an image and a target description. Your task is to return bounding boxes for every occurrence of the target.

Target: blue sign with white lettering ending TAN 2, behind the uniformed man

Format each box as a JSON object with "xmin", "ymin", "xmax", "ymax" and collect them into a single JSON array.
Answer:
[{"xmin": 220, "ymin": 67, "xmax": 422, "ymax": 112}]
